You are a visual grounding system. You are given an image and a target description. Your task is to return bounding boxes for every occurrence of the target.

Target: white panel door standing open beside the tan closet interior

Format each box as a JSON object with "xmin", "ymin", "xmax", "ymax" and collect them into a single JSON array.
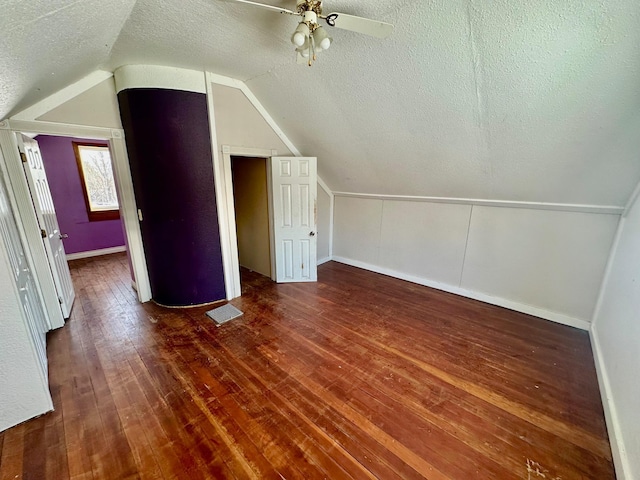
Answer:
[{"xmin": 271, "ymin": 157, "xmax": 318, "ymax": 283}]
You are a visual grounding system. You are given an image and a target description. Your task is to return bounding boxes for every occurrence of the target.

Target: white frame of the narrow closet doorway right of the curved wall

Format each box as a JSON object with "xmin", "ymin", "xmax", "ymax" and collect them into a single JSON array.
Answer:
[{"xmin": 215, "ymin": 145, "xmax": 278, "ymax": 300}]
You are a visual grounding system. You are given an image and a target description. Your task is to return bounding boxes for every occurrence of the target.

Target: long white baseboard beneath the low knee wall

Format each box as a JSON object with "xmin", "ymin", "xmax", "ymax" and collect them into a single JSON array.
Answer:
[{"xmin": 332, "ymin": 255, "xmax": 591, "ymax": 331}]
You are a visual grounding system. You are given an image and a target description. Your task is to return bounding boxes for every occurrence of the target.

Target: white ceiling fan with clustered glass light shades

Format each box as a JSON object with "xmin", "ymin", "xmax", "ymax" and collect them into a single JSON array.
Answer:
[{"xmin": 227, "ymin": 0, "xmax": 393, "ymax": 66}]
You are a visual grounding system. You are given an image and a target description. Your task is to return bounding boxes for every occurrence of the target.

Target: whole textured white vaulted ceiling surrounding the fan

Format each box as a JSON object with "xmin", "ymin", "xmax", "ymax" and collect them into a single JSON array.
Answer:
[{"xmin": 0, "ymin": 0, "xmax": 640, "ymax": 205}]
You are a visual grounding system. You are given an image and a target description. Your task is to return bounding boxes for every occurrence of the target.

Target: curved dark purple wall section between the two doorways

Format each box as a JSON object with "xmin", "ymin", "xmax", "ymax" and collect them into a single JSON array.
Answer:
[{"xmin": 118, "ymin": 89, "xmax": 226, "ymax": 306}]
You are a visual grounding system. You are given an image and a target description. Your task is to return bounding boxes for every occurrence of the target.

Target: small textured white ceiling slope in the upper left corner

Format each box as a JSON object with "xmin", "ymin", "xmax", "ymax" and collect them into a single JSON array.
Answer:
[{"xmin": 0, "ymin": 0, "xmax": 135, "ymax": 119}]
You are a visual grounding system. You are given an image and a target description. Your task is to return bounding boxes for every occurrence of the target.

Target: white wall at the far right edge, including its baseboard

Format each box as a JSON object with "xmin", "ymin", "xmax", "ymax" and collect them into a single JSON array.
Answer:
[{"xmin": 591, "ymin": 189, "xmax": 640, "ymax": 480}]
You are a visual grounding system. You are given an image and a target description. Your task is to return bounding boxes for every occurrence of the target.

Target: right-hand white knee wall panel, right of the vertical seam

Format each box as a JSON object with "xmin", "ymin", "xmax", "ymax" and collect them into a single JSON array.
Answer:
[{"xmin": 461, "ymin": 207, "xmax": 618, "ymax": 321}]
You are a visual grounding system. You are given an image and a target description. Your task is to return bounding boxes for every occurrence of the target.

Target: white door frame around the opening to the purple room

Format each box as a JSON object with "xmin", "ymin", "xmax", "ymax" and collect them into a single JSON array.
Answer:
[{"xmin": 0, "ymin": 120, "xmax": 151, "ymax": 328}]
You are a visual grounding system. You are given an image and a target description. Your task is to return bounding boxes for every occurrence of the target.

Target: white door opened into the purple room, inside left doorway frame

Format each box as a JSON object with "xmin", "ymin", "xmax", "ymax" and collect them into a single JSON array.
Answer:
[{"xmin": 18, "ymin": 135, "xmax": 76, "ymax": 318}]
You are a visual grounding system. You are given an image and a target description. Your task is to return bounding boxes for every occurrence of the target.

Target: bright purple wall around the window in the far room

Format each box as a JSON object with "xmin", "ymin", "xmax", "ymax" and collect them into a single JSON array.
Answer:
[{"xmin": 36, "ymin": 135, "xmax": 124, "ymax": 253}]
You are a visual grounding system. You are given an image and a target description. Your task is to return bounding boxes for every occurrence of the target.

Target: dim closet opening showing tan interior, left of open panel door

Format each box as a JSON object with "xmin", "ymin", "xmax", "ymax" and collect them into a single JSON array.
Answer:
[{"xmin": 231, "ymin": 156, "xmax": 273, "ymax": 279}]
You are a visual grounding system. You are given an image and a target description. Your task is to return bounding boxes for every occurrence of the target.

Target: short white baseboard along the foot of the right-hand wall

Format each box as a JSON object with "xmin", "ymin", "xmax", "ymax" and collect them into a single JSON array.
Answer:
[{"xmin": 589, "ymin": 325, "xmax": 632, "ymax": 480}]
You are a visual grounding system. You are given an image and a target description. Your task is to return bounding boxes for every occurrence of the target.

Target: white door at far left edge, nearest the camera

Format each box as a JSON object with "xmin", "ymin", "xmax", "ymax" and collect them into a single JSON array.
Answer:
[{"xmin": 0, "ymin": 161, "xmax": 49, "ymax": 372}]
